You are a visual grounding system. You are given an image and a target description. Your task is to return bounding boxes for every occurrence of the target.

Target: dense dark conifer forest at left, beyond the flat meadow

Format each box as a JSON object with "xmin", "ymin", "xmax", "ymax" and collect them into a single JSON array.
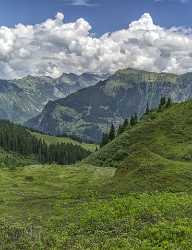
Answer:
[{"xmin": 0, "ymin": 121, "xmax": 90, "ymax": 164}]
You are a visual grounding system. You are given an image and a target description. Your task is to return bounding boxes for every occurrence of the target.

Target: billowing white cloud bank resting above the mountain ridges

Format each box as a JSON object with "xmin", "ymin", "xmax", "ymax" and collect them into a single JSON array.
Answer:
[{"xmin": 0, "ymin": 13, "xmax": 192, "ymax": 79}]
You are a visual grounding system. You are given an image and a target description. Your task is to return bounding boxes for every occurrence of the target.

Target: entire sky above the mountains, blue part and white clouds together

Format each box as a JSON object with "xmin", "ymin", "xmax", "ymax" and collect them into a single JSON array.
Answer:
[{"xmin": 0, "ymin": 0, "xmax": 192, "ymax": 79}]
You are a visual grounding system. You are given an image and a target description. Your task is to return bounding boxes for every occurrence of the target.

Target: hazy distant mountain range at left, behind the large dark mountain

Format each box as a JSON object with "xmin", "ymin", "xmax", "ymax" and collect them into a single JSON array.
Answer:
[{"xmin": 0, "ymin": 74, "xmax": 107, "ymax": 123}]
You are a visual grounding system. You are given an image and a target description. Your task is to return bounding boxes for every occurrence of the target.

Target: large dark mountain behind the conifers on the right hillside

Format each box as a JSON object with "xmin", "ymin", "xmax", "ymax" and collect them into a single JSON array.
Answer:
[{"xmin": 26, "ymin": 69, "xmax": 192, "ymax": 141}]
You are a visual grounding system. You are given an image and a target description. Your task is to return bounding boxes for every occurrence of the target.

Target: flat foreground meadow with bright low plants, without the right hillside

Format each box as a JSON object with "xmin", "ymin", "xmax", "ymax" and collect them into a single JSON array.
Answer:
[{"xmin": 0, "ymin": 165, "xmax": 192, "ymax": 250}]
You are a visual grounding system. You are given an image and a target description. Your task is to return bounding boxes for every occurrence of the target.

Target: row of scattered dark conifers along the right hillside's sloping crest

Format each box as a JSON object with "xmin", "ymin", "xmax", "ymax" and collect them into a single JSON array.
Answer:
[{"xmin": 100, "ymin": 96, "xmax": 172, "ymax": 148}]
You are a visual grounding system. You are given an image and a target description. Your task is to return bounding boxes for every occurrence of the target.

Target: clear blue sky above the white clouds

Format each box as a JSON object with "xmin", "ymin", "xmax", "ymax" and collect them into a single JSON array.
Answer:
[{"xmin": 0, "ymin": 0, "xmax": 192, "ymax": 35}]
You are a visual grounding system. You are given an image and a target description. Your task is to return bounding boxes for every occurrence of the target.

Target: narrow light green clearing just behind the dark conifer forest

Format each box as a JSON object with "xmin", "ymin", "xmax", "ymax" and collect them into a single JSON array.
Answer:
[{"xmin": 31, "ymin": 132, "xmax": 98, "ymax": 152}]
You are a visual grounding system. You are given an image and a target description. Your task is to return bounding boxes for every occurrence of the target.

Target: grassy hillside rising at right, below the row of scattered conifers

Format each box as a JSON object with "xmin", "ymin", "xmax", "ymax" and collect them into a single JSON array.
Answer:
[{"xmin": 86, "ymin": 101, "xmax": 192, "ymax": 191}]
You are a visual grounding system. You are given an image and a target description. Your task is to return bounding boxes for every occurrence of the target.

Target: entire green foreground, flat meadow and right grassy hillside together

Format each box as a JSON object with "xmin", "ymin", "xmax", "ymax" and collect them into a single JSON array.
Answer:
[{"xmin": 0, "ymin": 99, "xmax": 192, "ymax": 250}]
